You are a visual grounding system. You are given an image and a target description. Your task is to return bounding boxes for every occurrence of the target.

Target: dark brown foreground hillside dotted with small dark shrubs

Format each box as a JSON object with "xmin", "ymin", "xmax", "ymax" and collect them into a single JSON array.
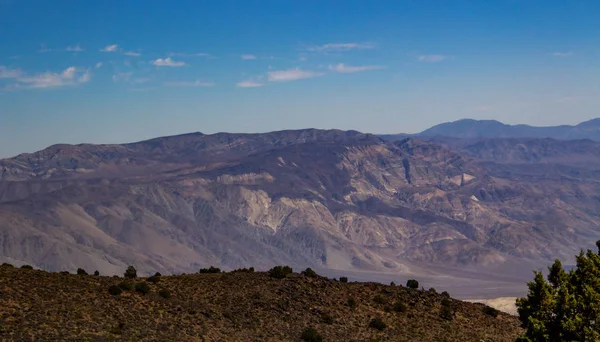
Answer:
[{"xmin": 0, "ymin": 266, "xmax": 521, "ymax": 341}]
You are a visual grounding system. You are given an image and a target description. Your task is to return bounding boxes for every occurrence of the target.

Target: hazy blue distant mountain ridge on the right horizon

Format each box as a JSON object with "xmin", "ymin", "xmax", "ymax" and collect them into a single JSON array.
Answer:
[{"xmin": 416, "ymin": 118, "xmax": 600, "ymax": 141}]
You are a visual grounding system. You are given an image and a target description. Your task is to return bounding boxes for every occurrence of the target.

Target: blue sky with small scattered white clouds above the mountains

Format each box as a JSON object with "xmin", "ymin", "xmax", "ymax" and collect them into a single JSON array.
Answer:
[{"xmin": 0, "ymin": 0, "xmax": 600, "ymax": 157}]
